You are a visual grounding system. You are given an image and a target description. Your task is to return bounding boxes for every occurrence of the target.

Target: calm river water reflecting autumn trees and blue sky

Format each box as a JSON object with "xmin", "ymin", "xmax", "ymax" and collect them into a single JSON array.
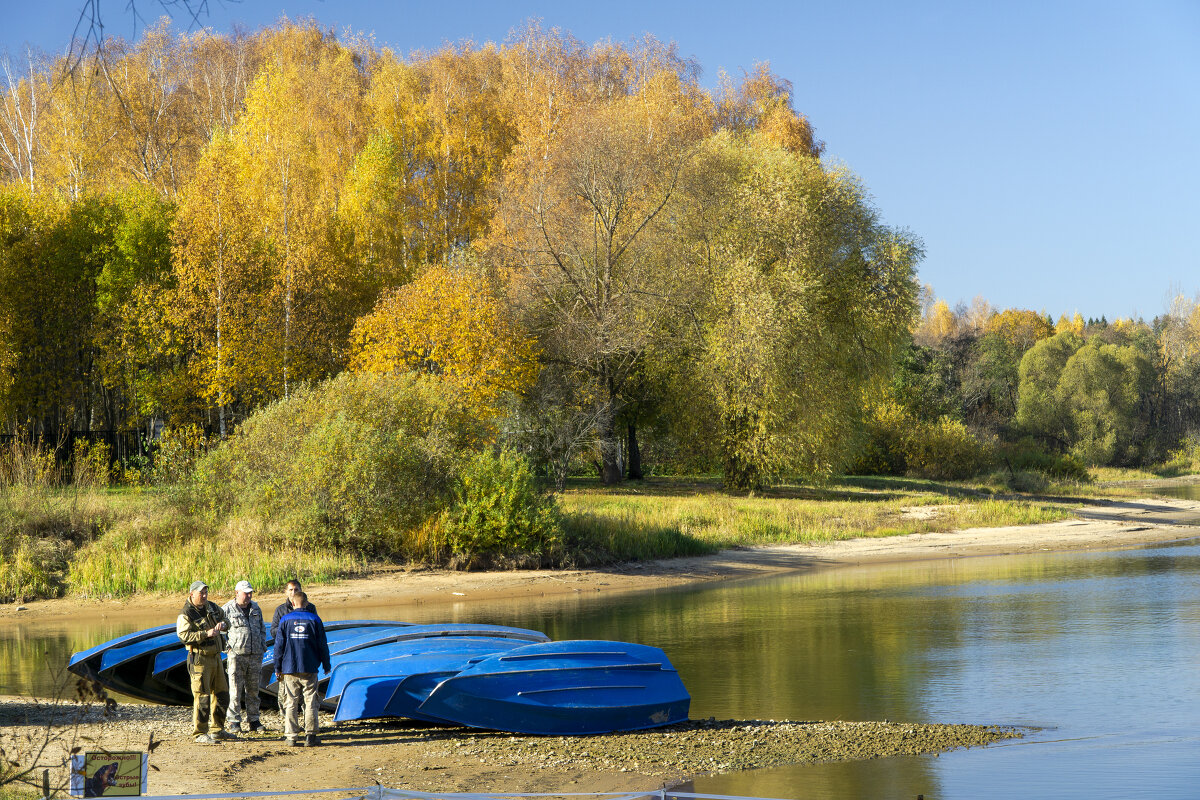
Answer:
[{"xmin": 0, "ymin": 543, "xmax": 1200, "ymax": 800}]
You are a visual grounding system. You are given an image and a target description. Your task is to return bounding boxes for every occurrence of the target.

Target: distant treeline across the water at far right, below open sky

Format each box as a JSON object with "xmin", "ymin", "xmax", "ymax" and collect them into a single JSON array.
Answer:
[{"xmin": 873, "ymin": 294, "xmax": 1200, "ymax": 474}]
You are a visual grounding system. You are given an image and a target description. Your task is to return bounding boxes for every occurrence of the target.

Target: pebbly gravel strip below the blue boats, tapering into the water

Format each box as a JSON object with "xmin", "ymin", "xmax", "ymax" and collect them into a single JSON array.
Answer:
[{"xmin": 0, "ymin": 698, "xmax": 1024, "ymax": 781}]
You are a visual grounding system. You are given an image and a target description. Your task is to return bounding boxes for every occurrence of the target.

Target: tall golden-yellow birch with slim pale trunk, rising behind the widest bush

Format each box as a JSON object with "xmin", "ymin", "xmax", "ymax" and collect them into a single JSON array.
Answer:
[{"xmin": 230, "ymin": 26, "xmax": 362, "ymax": 396}]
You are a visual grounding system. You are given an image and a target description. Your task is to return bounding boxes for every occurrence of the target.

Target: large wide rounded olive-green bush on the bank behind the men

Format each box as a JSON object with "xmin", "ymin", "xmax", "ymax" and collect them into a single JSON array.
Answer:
[{"xmin": 186, "ymin": 373, "xmax": 486, "ymax": 555}]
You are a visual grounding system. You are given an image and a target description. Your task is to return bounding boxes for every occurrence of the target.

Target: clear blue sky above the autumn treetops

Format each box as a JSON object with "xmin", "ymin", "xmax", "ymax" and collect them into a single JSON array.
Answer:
[{"xmin": 0, "ymin": 0, "xmax": 1200, "ymax": 320}]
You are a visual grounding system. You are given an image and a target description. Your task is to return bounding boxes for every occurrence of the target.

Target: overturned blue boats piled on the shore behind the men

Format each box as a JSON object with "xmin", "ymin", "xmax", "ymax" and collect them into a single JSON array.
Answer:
[{"xmin": 67, "ymin": 620, "xmax": 691, "ymax": 735}]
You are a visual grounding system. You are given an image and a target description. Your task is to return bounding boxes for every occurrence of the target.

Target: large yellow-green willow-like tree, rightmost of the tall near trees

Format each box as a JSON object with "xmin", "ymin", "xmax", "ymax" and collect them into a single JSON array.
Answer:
[{"xmin": 698, "ymin": 136, "xmax": 920, "ymax": 488}]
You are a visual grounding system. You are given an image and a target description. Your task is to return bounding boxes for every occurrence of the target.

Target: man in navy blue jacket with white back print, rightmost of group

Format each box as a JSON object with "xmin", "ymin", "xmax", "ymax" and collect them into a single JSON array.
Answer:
[{"xmin": 275, "ymin": 591, "xmax": 334, "ymax": 747}]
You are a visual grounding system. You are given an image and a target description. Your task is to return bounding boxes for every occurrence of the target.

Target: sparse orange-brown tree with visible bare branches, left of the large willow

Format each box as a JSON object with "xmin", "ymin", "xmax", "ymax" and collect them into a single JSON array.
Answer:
[{"xmin": 492, "ymin": 44, "xmax": 707, "ymax": 483}]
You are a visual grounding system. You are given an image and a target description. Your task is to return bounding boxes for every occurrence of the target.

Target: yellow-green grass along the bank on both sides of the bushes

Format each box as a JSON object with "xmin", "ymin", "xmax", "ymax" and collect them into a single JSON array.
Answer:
[{"xmin": 0, "ymin": 474, "xmax": 1161, "ymax": 602}]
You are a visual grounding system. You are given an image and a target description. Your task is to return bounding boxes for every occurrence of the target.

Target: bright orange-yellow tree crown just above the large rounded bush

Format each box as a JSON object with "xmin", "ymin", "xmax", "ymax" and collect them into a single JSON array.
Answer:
[{"xmin": 350, "ymin": 266, "xmax": 538, "ymax": 419}]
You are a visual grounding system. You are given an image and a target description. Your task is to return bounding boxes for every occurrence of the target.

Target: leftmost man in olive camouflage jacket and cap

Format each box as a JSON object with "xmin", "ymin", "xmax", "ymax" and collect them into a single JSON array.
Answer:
[{"xmin": 175, "ymin": 581, "xmax": 233, "ymax": 745}]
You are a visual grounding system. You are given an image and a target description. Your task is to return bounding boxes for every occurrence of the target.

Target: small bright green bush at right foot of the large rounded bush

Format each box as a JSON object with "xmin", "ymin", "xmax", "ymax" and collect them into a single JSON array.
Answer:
[{"xmin": 442, "ymin": 450, "xmax": 563, "ymax": 570}]
